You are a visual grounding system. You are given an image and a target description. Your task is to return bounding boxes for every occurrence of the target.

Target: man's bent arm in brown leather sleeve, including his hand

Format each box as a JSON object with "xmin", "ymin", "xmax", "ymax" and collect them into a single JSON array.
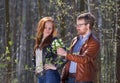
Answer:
[{"xmin": 58, "ymin": 42, "xmax": 99, "ymax": 64}]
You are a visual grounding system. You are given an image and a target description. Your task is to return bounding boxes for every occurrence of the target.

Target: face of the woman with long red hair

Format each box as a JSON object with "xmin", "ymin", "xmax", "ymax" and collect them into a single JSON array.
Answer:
[{"xmin": 43, "ymin": 21, "xmax": 53, "ymax": 38}]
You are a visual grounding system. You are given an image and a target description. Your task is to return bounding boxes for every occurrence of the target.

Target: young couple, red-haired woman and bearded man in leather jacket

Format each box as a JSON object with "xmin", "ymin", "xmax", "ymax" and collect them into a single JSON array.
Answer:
[{"xmin": 34, "ymin": 13, "xmax": 100, "ymax": 83}]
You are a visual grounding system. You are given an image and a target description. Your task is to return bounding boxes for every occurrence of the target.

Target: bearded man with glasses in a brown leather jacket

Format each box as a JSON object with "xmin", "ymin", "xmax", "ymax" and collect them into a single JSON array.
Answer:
[{"xmin": 57, "ymin": 13, "xmax": 100, "ymax": 83}]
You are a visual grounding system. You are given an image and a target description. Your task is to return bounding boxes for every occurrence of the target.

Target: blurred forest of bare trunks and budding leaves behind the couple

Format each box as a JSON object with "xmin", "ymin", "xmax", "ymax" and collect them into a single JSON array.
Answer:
[{"xmin": 0, "ymin": 0, "xmax": 120, "ymax": 83}]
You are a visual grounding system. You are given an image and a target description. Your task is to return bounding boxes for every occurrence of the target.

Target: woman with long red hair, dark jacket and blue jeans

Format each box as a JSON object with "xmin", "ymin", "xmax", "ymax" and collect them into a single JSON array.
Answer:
[{"xmin": 34, "ymin": 17, "xmax": 64, "ymax": 83}]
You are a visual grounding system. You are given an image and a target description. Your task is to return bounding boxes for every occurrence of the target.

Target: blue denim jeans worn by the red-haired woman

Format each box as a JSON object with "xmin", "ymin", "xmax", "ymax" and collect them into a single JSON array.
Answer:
[{"xmin": 38, "ymin": 70, "xmax": 60, "ymax": 83}]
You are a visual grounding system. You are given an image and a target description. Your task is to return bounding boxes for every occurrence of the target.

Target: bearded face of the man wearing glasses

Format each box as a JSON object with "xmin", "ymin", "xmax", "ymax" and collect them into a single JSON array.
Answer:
[{"xmin": 76, "ymin": 19, "xmax": 88, "ymax": 35}]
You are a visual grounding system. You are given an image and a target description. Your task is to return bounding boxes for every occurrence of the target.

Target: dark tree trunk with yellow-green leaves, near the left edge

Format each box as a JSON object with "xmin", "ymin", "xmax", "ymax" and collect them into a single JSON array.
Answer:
[{"xmin": 5, "ymin": 0, "xmax": 12, "ymax": 83}]
